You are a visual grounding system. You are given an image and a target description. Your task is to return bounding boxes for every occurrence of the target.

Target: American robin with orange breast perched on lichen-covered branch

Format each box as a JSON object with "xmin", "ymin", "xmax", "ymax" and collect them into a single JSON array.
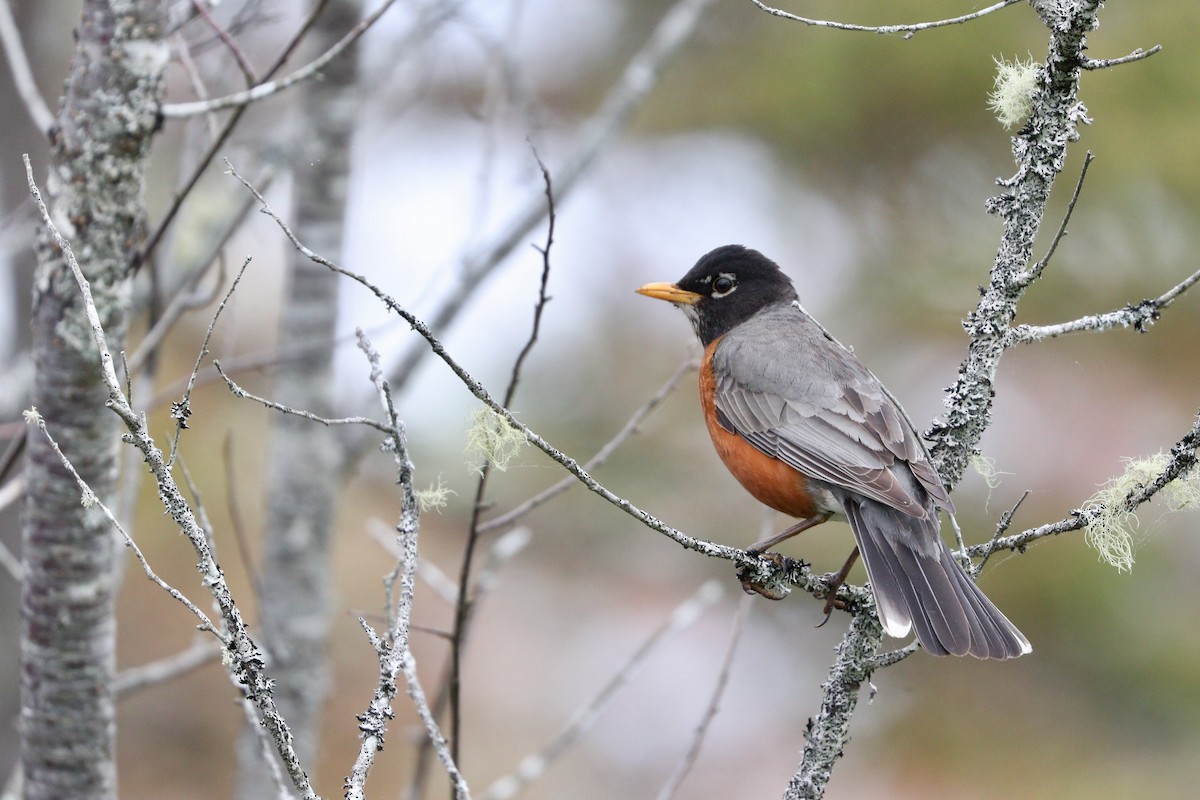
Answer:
[{"xmin": 637, "ymin": 245, "xmax": 1032, "ymax": 658}]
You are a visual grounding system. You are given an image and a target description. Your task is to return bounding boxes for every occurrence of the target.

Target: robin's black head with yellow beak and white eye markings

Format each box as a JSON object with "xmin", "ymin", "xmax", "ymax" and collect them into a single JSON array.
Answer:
[{"xmin": 637, "ymin": 245, "xmax": 797, "ymax": 347}]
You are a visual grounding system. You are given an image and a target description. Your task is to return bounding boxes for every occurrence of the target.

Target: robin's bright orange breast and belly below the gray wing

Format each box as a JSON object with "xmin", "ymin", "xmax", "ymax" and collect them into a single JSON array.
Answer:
[{"xmin": 700, "ymin": 338, "xmax": 820, "ymax": 519}]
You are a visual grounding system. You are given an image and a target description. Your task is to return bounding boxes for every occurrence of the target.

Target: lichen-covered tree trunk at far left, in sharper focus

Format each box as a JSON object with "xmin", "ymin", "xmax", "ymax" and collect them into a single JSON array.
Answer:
[{"xmin": 20, "ymin": 0, "xmax": 168, "ymax": 800}]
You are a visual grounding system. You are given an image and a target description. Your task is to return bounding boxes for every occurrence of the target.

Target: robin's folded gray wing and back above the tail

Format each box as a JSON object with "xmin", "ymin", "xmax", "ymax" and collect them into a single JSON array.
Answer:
[{"xmin": 713, "ymin": 305, "xmax": 954, "ymax": 517}]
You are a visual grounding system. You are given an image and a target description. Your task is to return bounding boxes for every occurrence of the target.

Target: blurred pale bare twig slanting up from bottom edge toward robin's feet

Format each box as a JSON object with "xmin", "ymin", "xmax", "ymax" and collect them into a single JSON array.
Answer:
[{"xmin": 482, "ymin": 581, "xmax": 722, "ymax": 800}]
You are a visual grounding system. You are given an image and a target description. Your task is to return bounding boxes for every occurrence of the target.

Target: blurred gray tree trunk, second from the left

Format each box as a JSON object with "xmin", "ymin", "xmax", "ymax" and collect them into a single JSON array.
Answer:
[{"xmin": 238, "ymin": 0, "xmax": 362, "ymax": 800}]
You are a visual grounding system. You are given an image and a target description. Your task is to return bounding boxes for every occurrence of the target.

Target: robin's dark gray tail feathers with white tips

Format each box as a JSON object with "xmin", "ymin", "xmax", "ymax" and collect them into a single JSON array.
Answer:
[{"xmin": 842, "ymin": 498, "xmax": 1033, "ymax": 658}]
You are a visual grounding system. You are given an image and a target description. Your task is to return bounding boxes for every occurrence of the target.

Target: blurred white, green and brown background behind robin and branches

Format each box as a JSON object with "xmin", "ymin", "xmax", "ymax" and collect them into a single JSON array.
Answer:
[{"xmin": 0, "ymin": 0, "xmax": 1200, "ymax": 800}]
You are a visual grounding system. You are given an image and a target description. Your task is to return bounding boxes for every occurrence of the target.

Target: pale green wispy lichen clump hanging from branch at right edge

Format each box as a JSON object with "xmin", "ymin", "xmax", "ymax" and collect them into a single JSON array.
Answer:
[{"xmin": 1084, "ymin": 452, "xmax": 1200, "ymax": 572}]
